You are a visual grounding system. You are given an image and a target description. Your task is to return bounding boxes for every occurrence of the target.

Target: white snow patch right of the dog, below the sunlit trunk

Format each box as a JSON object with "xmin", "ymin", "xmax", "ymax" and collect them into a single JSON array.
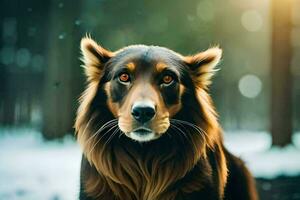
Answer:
[{"xmin": 225, "ymin": 132, "xmax": 300, "ymax": 179}]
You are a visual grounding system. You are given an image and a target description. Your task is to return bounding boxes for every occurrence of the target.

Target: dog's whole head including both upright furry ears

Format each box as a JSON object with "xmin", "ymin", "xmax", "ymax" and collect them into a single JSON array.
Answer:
[{"xmin": 81, "ymin": 38, "xmax": 221, "ymax": 142}]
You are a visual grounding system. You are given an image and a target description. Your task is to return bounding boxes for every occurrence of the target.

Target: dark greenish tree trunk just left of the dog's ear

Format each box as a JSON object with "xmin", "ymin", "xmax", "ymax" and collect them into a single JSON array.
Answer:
[{"xmin": 42, "ymin": 0, "xmax": 80, "ymax": 139}]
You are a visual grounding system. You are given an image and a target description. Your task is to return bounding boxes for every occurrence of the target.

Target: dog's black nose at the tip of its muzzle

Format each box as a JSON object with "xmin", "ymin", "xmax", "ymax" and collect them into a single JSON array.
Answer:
[{"xmin": 131, "ymin": 105, "xmax": 155, "ymax": 123}]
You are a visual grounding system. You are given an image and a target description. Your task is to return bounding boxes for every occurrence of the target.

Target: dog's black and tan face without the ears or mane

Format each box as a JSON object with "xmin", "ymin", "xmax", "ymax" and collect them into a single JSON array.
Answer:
[{"xmin": 105, "ymin": 46, "xmax": 184, "ymax": 141}]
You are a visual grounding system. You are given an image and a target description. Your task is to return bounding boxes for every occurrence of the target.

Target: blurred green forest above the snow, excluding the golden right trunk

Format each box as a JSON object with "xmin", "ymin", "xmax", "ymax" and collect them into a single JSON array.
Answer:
[{"xmin": 0, "ymin": 0, "xmax": 300, "ymax": 141}]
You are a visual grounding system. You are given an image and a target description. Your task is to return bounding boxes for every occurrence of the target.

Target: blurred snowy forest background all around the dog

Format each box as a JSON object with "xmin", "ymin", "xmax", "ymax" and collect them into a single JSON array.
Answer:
[{"xmin": 0, "ymin": 0, "xmax": 300, "ymax": 200}]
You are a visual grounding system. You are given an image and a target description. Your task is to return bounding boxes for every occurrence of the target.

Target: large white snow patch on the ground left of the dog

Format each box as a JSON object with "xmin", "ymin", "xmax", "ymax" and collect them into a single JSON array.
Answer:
[{"xmin": 0, "ymin": 129, "xmax": 81, "ymax": 200}]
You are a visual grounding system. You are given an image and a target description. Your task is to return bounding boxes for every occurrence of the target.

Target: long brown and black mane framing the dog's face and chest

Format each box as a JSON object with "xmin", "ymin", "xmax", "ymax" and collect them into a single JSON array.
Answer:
[{"xmin": 75, "ymin": 39, "xmax": 256, "ymax": 200}]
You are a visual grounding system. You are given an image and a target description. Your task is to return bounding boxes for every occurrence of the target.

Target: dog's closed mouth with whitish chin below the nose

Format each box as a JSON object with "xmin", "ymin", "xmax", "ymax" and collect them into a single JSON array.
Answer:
[{"xmin": 126, "ymin": 126, "xmax": 159, "ymax": 142}]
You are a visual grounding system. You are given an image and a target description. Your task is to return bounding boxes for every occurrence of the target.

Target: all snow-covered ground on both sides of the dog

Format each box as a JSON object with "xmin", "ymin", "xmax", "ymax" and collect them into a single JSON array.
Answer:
[{"xmin": 0, "ymin": 129, "xmax": 300, "ymax": 200}]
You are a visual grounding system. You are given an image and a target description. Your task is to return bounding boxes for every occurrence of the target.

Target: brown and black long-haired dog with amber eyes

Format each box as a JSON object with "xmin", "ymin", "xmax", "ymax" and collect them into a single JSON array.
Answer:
[{"xmin": 75, "ymin": 37, "xmax": 257, "ymax": 200}]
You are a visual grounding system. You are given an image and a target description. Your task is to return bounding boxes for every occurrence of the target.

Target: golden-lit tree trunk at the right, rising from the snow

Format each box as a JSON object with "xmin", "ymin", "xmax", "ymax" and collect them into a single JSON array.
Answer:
[{"xmin": 271, "ymin": 0, "xmax": 292, "ymax": 147}]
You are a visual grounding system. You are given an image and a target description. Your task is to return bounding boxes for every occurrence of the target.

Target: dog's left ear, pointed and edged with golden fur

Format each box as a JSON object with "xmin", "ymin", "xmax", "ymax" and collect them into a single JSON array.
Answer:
[{"xmin": 80, "ymin": 37, "xmax": 114, "ymax": 81}]
